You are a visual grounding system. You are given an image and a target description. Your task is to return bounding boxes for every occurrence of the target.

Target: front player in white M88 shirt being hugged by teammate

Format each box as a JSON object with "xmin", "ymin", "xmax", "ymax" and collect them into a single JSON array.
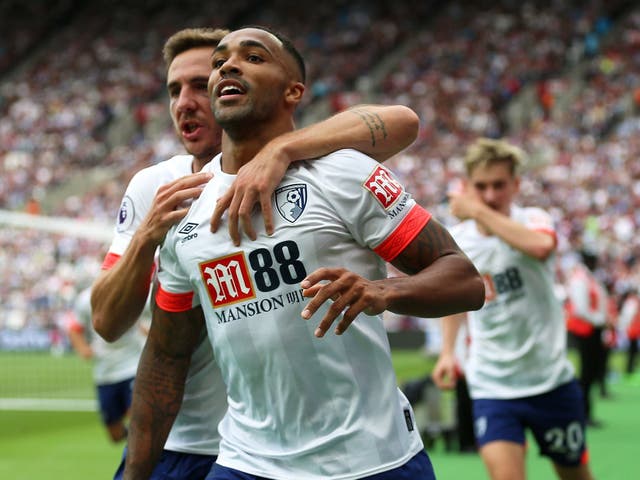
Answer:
[{"xmin": 125, "ymin": 28, "xmax": 484, "ymax": 480}]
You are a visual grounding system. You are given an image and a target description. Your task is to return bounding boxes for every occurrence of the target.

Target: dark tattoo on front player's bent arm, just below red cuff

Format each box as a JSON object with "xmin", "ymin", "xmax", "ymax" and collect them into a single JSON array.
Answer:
[{"xmin": 393, "ymin": 218, "xmax": 460, "ymax": 275}]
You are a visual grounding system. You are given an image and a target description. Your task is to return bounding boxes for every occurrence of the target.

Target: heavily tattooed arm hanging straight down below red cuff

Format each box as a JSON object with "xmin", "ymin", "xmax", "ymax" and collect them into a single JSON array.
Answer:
[{"xmin": 124, "ymin": 307, "xmax": 206, "ymax": 480}]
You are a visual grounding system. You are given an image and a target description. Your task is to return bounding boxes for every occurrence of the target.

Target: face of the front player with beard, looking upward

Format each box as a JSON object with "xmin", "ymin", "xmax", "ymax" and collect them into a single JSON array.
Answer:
[{"xmin": 209, "ymin": 28, "xmax": 302, "ymax": 128}]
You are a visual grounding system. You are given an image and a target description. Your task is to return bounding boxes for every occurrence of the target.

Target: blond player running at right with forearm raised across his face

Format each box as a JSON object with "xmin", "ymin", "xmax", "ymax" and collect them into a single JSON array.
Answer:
[{"xmin": 432, "ymin": 139, "xmax": 592, "ymax": 480}]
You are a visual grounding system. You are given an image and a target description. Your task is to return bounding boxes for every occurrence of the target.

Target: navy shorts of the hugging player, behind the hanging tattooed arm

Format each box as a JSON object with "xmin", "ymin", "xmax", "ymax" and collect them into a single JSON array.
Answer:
[{"xmin": 113, "ymin": 447, "xmax": 216, "ymax": 480}]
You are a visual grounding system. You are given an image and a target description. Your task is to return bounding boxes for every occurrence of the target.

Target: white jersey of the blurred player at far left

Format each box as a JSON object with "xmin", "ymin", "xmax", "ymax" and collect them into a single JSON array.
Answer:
[{"xmin": 73, "ymin": 288, "xmax": 145, "ymax": 385}]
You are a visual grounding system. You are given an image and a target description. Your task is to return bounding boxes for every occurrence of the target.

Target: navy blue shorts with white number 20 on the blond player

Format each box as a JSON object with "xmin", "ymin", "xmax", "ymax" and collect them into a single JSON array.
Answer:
[{"xmin": 473, "ymin": 380, "xmax": 586, "ymax": 467}]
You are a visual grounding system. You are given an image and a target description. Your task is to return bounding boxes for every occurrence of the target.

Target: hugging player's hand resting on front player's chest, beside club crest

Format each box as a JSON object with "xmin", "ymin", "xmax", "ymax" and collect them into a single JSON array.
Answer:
[{"xmin": 211, "ymin": 140, "xmax": 291, "ymax": 245}]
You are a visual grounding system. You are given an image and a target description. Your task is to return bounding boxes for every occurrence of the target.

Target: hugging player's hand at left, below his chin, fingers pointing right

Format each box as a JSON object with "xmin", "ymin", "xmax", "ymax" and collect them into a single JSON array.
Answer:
[{"xmin": 138, "ymin": 172, "xmax": 213, "ymax": 245}]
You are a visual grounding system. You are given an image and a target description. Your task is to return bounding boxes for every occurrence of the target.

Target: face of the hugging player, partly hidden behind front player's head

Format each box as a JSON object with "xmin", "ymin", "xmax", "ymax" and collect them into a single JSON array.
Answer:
[{"xmin": 167, "ymin": 47, "xmax": 222, "ymax": 162}]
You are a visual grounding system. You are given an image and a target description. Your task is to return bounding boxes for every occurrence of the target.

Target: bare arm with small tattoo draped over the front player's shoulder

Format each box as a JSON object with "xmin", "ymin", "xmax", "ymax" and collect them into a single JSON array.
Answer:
[{"xmin": 211, "ymin": 105, "xmax": 419, "ymax": 245}]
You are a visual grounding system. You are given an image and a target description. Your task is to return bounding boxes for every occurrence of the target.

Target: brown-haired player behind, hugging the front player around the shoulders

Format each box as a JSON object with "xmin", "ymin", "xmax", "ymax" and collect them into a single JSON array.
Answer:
[{"xmin": 92, "ymin": 29, "xmax": 418, "ymax": 480}]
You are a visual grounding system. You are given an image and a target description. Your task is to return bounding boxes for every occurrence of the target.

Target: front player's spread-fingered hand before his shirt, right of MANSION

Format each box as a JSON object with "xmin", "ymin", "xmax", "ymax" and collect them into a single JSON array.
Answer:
[{"xmin": 301, "ymin": 268, "xmax": 387, "ymax": 337}]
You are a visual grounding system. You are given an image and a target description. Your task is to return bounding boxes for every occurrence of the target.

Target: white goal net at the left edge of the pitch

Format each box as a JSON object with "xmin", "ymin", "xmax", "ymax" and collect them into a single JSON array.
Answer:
[{"xmin": 0, "ymin": 210, "xmax": 113, "ymax": 410}]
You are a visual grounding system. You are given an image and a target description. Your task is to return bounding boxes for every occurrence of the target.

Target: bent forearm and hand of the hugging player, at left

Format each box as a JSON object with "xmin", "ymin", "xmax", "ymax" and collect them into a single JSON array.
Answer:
[{"xmin": 91, "ymin": 173, "xmax": 211, "ymax": 342}]
